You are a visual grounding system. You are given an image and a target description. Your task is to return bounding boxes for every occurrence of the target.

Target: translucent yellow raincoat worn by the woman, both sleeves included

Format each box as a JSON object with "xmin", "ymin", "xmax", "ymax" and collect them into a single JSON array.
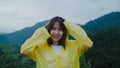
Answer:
[{"xmin": 21, "ymin": 21, "xmax": 93, "ymax": 68}]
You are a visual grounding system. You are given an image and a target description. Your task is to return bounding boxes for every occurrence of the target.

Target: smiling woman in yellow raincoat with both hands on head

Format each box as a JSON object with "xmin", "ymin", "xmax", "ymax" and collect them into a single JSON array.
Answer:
[{"xmin": 21, "ymin": 16, "xmax": 93, "ymax": 68}]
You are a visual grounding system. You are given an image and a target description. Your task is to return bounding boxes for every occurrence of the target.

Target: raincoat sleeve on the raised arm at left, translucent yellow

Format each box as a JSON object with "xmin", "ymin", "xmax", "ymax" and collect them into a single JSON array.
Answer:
[{"xmin": 20, "ymin": 27, "xmax": 50, "ymax": 60}]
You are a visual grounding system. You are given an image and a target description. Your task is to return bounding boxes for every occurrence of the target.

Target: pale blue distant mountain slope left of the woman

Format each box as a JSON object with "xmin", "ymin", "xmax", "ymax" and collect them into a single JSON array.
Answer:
[{"xmin": 0, "ymin": 20, "xmax": 49, "ymax": 45}]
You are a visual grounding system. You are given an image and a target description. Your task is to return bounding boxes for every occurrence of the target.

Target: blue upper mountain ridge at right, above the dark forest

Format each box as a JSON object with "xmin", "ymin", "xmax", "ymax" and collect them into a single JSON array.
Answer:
[{"xmin": 82, "ymin": 12, "xmax": 120, "ymax": 34}]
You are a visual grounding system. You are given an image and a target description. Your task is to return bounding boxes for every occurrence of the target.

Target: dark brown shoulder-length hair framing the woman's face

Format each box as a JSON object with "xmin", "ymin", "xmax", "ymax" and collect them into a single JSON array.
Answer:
[{"xmin": 45, "ymin": 16, "xmax": 67, "ymax": 48}]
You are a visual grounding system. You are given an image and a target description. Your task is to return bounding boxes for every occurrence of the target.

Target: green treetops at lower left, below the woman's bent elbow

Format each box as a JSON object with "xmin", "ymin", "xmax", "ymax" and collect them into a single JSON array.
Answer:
[{"xmin": 0, "ymin": 44, "xmax": 35, "ymax": 68}]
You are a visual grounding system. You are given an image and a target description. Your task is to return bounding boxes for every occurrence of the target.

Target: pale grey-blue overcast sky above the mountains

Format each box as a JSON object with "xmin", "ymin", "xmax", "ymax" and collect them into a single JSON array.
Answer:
[{"xmin": 0, "ymin": 0, "xmax": 120, "ymax": 33}]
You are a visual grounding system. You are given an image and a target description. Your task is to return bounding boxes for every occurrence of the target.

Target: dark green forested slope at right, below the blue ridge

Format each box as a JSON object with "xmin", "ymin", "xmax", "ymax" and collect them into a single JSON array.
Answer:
[{"xmin": 86, "ymin": 22, "xmax": 120, "ymax": 68}]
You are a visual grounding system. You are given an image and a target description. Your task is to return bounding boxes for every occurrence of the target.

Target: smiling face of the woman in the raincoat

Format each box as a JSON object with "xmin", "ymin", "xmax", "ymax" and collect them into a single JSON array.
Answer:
[{"xmin": 50, "ymin": 22, "xmax": 63, "ymax": 43}]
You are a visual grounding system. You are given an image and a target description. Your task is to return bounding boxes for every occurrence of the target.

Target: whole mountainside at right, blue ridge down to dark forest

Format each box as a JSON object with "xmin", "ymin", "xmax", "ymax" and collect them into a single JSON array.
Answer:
[{"xmin": 84, "ymin": 12, "xmax": 120, "ymax": 68}]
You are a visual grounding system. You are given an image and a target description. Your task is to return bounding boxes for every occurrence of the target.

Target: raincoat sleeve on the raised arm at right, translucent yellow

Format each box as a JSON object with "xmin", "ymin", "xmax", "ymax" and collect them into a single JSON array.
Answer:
[{"xmin": 64, "ymin": 20, "xmax": 93, "ymax": 56}]
